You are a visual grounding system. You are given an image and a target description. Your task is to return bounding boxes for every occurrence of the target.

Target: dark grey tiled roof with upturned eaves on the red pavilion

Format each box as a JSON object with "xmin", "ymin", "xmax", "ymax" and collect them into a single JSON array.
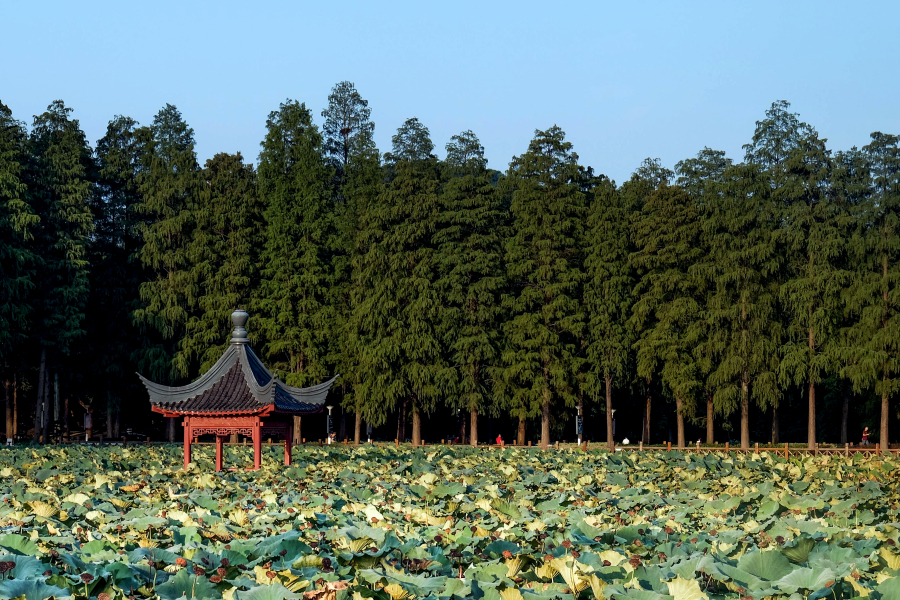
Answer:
[{"xmin": 138, "ymin": 311, "xmax": 338, "ymax": 415}]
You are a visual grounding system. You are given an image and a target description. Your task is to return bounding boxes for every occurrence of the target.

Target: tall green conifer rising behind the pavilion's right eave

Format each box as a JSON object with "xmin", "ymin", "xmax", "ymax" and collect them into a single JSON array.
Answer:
[{"xmin": 253, "ymin": 100, "xmax": 333, "ymax": 386}]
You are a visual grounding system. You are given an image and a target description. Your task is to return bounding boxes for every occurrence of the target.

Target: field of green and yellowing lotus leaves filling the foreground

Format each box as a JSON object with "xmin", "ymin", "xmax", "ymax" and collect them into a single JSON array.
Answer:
[{"xmin": 0, "ymin": 445, "xmax": 900, "ymax": 600}]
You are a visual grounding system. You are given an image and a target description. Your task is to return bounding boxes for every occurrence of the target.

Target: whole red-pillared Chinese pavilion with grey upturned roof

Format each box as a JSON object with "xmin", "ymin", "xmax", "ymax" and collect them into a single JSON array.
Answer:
[{"xmin": 138, "ymin": 310, "xmax": 338, "ymax": 471}]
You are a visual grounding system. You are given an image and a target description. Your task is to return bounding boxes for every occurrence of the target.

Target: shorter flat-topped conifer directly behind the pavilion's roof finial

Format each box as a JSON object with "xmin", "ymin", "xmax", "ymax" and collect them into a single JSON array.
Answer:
[{"xmin": 182, "ymin": 153, "xmax": 263, "ymax": 373}]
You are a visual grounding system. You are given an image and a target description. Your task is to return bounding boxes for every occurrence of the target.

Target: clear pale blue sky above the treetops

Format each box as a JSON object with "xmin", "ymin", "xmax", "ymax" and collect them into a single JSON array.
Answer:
[{"xmin": 0, "ymin": 0, "xmax": 900, "ymax": 183}]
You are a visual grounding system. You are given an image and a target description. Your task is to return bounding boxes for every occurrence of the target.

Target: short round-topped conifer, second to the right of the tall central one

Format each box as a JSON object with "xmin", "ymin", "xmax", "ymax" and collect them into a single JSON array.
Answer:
[{"xmin": 630, "ymin": 183, "xmax": 704, "ymax": 448}]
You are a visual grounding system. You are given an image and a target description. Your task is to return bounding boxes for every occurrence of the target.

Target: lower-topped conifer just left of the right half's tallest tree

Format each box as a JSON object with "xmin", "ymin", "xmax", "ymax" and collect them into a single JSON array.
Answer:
[{"xmin": 695, "ymin": 164, "xmax": 783, "ymax": 449}]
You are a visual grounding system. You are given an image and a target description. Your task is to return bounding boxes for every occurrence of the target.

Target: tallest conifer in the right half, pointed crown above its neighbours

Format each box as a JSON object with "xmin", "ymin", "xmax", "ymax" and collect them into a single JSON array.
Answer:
[{"xmin": 746, "ymin": 101, "xmax": 846, "ymax": 448}]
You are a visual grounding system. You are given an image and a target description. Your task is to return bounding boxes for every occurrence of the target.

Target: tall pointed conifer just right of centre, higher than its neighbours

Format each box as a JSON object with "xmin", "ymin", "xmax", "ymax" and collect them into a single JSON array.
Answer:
[{"xmin": 502, "ymin": 126, "xmax": 587, "ymax": 448}]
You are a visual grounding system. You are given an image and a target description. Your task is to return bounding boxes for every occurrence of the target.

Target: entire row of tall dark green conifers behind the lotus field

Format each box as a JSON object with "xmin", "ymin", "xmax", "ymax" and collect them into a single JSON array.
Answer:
[{"xmin": 0, "ymin": 82, "xmax": 900, "ymax": 448}]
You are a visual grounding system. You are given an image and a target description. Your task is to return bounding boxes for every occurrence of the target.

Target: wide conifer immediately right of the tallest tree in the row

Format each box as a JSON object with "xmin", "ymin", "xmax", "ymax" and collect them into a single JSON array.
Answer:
[{"xmin": 351, "ymin": 118, "xmax": 451, "ymax": 444}]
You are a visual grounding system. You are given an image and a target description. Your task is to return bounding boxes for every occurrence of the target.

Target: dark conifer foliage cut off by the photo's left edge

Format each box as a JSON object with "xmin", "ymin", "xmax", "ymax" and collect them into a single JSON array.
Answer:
[{"xmin": 0, "ymin": 103, "xmax": 40, "ymax": 360}]
